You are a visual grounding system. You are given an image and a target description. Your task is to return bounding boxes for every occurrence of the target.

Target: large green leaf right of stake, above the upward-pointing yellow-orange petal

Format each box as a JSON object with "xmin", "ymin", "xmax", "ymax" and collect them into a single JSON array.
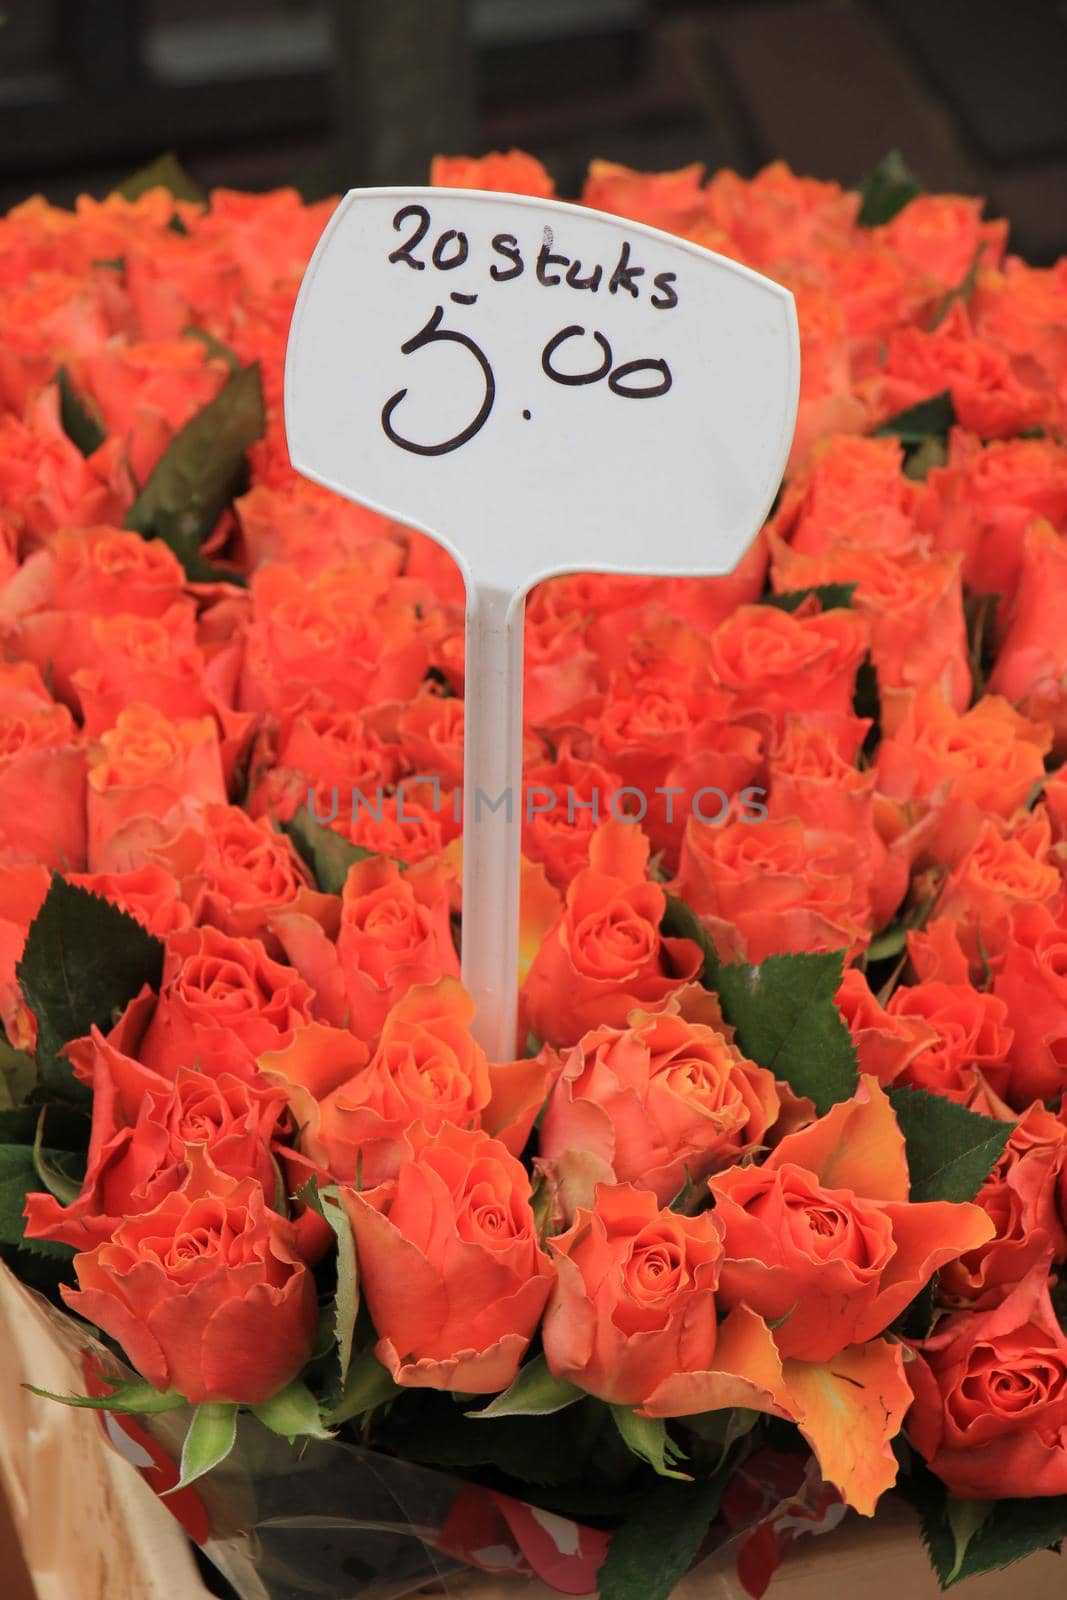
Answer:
[{"xmin": 715, "ymin": 950, "xmax": 859, "ymax": 1112}]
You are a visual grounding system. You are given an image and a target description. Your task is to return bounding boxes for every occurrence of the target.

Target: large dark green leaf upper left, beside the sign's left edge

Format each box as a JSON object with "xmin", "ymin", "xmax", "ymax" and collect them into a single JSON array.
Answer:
[{"xmin": 125, "ymin": 365, "xmax": 266, "ymax": 582}]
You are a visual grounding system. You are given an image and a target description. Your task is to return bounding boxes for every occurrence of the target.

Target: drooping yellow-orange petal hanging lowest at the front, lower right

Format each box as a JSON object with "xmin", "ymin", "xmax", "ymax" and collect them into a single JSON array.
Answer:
[{"xmin": 782, "ymin": 1339, "xmax": 912, "ymax": 1517}]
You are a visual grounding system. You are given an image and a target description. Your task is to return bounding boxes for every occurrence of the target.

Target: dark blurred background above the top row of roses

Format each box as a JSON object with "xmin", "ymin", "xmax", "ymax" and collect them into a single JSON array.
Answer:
[{"xmin": 0, "ymin": 0, "xmax": 1067, "ymax": 262}]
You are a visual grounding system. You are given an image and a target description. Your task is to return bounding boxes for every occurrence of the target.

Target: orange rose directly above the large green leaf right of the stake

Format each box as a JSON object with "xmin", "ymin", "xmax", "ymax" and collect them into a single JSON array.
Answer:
[{"xmin": 677, "ymin": 816, "xmax": 870, "ymax": 962}]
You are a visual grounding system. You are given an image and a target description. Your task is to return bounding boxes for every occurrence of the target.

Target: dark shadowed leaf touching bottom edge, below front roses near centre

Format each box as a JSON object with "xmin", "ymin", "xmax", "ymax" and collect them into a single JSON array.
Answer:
[{"xmin": 597, "ymin": 1477, "xmax": 725, "ymax": 1600}]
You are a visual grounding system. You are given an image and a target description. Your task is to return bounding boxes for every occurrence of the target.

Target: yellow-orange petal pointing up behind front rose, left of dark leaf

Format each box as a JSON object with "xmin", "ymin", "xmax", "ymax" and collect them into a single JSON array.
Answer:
[{"xmin": 766, "ymin": 1077, "xmax": 909, "ymax": 1200}]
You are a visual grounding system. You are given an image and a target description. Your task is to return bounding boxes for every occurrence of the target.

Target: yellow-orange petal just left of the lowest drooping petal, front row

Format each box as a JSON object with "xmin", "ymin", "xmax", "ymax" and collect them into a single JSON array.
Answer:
[{"xmin": 640, "ymin": 1306, "xmax": 797, "ymax": 1418}]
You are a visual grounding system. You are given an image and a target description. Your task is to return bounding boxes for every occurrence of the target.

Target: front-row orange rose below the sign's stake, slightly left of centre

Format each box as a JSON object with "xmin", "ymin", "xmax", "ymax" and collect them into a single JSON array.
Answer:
[{"xmin": 341, "ymin": 1128, "xmax": 552, "ymax": 1394}]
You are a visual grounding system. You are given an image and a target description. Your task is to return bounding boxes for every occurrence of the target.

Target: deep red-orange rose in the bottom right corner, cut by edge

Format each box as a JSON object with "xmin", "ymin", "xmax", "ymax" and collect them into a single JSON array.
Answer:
[{"xmin": 907, "ymin": 1264, "xmax": 1067, "ymax": 1499}]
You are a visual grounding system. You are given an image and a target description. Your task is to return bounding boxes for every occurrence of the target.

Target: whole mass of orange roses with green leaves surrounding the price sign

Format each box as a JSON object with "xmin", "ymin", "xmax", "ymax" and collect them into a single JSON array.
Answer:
[{"xmin": 0, "ymin": 144, "xmax": 1067, "ymax": 1600}]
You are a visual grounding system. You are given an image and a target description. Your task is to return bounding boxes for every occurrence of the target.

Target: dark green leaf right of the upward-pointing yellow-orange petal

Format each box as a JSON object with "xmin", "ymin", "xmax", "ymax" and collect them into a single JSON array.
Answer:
[{"xmin": 889, "ymin": 1088, "xmax": 1014, "ymax": 1200}]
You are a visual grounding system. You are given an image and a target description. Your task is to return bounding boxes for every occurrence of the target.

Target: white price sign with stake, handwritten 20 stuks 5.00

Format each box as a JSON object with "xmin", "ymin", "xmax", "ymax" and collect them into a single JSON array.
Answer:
[{"xmin": 285, "ymin": 189, "xmax": 800, "ymax": 1059}]
